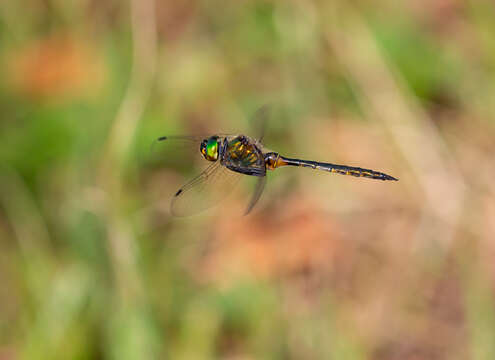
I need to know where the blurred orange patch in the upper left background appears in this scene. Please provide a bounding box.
[7,35,104,99]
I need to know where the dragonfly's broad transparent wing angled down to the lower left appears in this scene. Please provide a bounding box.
[170,161,242,216]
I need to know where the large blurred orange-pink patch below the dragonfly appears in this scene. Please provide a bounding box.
[194,197,343,282]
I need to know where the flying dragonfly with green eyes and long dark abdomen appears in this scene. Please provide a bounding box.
[156,106,398,216]
